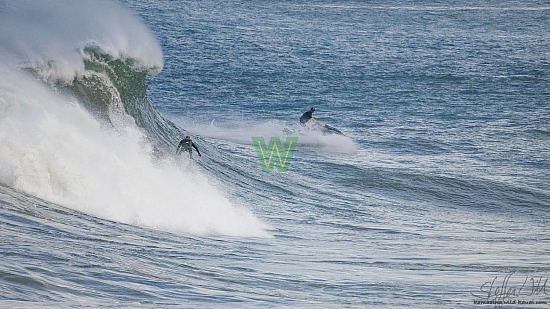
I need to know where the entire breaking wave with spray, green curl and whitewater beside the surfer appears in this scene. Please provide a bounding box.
[0,1,268,236]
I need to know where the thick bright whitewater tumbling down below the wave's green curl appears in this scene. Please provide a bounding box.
[0,69,269,237]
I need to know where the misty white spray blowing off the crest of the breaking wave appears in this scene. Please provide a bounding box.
[0,0,163,81]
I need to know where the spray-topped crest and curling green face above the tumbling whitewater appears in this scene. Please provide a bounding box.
[0,1,178,145]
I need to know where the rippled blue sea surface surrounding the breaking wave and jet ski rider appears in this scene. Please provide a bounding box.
[0,0,550,308]
